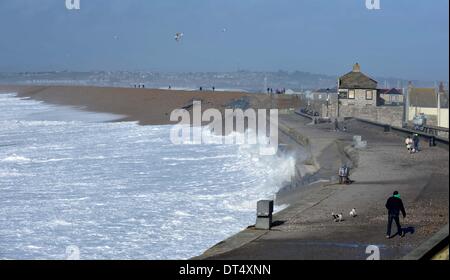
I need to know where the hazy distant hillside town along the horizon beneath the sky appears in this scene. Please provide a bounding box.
[0,69,442,94]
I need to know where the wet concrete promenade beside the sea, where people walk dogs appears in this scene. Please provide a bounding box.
[198,114,449,260]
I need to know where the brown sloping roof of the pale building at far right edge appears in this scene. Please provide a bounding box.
[409,88,448,108]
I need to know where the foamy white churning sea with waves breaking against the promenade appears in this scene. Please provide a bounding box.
[0,94,295,259]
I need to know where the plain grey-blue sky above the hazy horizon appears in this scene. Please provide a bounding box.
[0,0,449,81]
